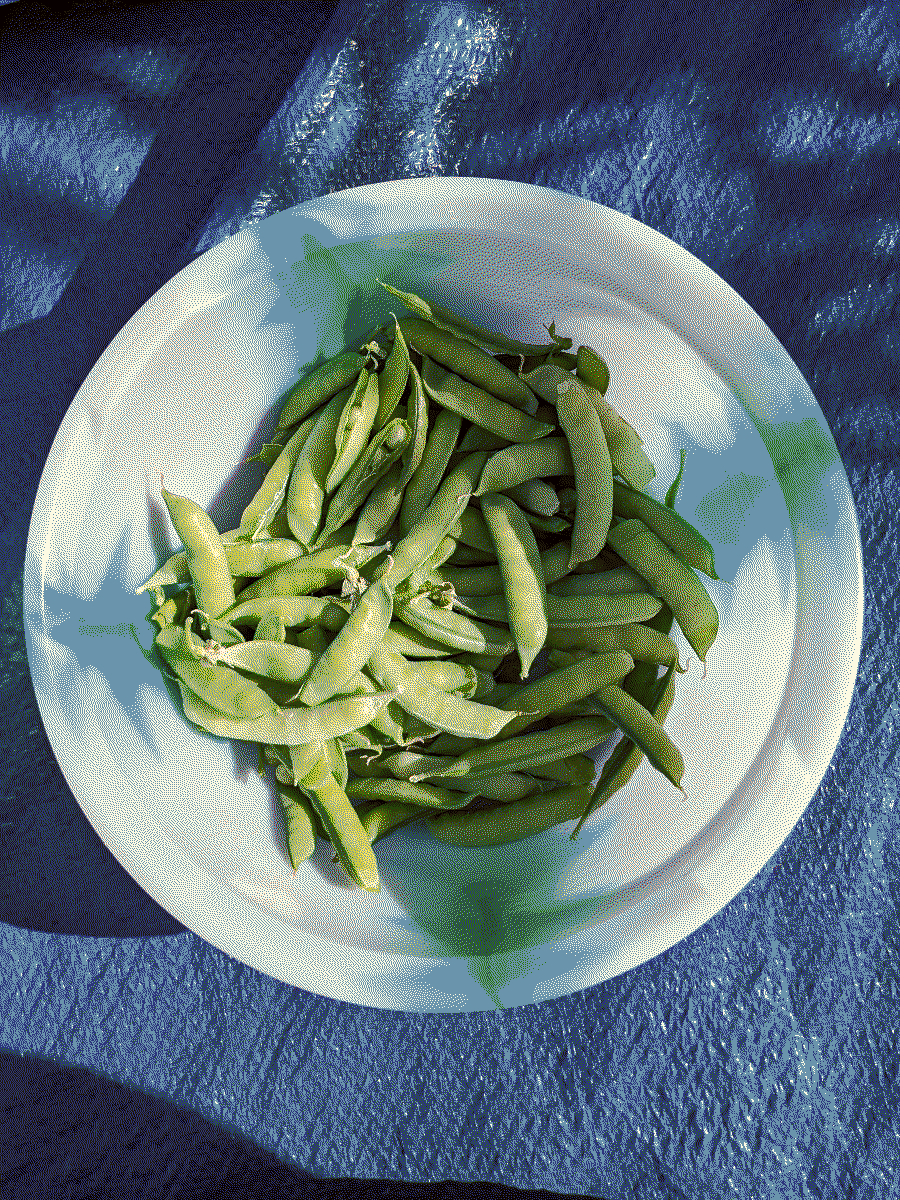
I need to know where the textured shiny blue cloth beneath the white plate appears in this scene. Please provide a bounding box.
[0,0,900,1200]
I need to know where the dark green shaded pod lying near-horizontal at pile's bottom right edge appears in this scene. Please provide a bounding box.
[427,787,590,847]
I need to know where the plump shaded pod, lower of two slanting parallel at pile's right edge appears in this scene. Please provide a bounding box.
[610,520,719,662]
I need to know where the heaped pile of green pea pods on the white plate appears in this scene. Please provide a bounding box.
[138,284,719,890]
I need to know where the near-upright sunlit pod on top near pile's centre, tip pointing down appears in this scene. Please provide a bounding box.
[481,492,548,679]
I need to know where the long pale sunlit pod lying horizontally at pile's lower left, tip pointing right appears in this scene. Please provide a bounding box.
[179,680,396,746]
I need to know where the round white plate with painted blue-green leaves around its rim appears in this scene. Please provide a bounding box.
[25,179,863,1012]
